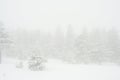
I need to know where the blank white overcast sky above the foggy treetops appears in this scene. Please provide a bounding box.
[0,0,120,31]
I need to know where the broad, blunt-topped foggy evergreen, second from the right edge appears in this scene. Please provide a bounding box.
[89,29,110,63]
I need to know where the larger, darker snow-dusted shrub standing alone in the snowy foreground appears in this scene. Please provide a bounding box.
[28,56,46,71]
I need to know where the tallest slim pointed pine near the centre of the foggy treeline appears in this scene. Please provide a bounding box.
[64,24,76,63]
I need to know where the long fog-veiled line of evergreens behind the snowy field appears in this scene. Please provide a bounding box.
[7,25,120,63]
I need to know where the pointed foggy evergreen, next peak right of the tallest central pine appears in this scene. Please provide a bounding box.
[74,27,89,62]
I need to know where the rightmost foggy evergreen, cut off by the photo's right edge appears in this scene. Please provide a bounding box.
[108,27,120,62]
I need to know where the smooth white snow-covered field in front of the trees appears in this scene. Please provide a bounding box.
[0,59,120,80]
